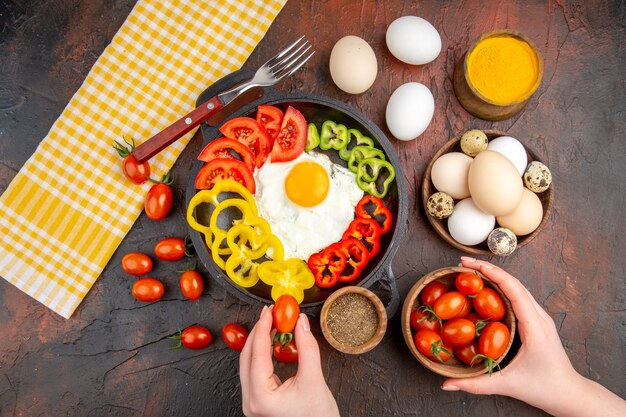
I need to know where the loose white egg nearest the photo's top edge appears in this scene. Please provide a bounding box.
[385,16,441,65]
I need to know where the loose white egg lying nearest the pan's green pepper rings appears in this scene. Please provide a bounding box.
[385,82,435,140]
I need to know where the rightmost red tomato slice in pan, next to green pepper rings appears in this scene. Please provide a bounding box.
[271,106,308,162]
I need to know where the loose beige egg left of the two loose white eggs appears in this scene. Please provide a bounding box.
[329,35,378,94]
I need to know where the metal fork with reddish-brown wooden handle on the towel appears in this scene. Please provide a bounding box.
[132,36,315,162]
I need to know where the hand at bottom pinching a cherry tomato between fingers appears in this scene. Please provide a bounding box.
[239,307,339,417]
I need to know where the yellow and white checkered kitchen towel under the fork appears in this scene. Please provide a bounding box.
[0,0,287,318]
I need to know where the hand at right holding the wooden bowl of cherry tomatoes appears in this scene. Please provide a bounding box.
[442,257,626,416]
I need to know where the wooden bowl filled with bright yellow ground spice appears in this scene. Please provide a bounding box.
[453,29,543,120]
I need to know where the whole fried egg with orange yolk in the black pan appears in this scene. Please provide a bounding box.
[254,152,363,261]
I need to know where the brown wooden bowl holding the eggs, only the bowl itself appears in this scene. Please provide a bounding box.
[422,129,554,256]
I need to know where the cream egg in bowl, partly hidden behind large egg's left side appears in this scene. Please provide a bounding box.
[430,152,473,200]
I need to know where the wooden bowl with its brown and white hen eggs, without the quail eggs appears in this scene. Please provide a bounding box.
[422,129,553,256]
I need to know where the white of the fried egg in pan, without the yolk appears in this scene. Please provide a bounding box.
[254,152,363,260]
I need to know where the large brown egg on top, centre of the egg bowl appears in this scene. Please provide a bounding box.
[468,150,524,216]
